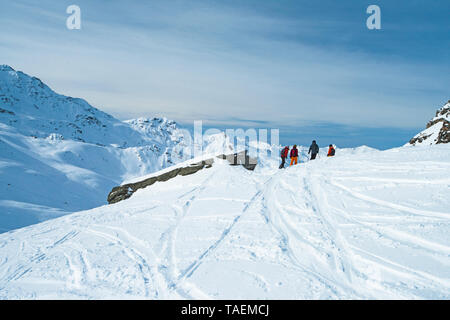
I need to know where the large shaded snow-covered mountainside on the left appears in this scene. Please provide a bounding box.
[0,65,190,232]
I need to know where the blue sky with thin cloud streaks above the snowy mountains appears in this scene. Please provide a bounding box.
[0,0,450,149]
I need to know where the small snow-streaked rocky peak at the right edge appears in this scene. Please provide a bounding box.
[408,100,450,145]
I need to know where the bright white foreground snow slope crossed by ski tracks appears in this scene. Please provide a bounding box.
[0,145,450,299]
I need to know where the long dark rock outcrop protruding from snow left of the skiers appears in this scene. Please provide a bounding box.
[107,150,257,204]
